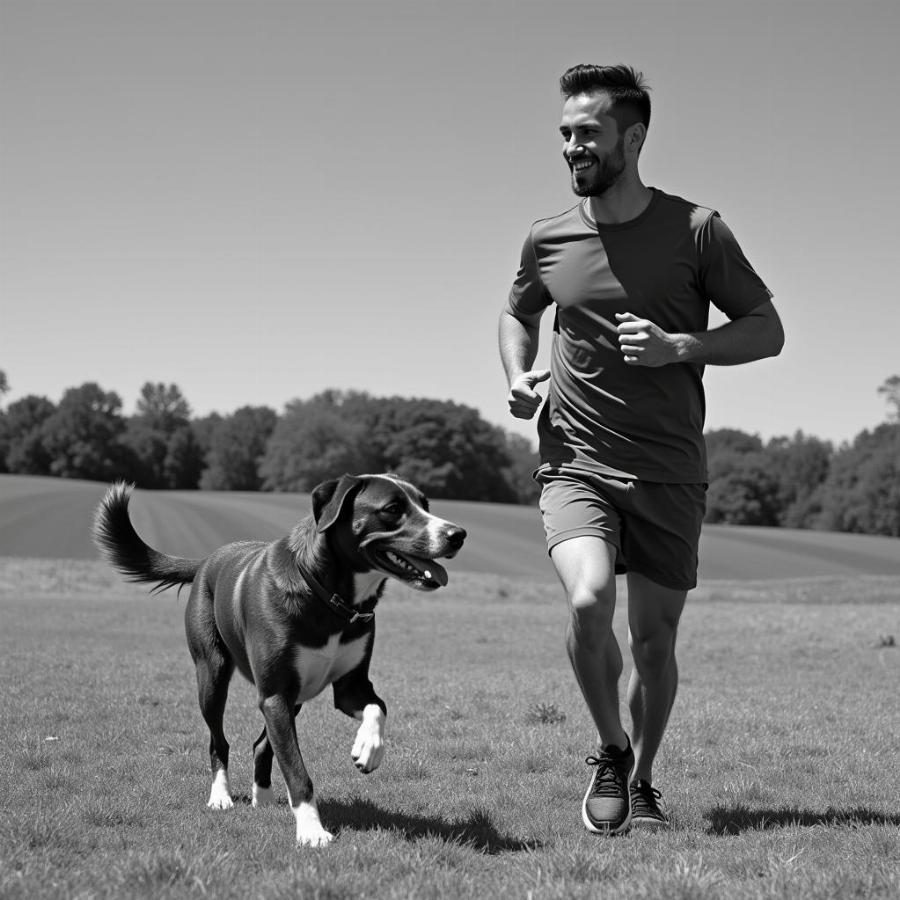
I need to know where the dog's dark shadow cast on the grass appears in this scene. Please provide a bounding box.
[235,795,542,856]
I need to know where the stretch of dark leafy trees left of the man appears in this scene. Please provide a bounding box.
[0,373,537,503]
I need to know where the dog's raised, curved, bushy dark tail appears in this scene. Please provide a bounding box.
[94,481,202,591]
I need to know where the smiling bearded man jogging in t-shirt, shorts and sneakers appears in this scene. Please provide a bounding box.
[500,65,784,834]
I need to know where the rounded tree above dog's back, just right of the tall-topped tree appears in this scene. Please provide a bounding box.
[200,406,278,491]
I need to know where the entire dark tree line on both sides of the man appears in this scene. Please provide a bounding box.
[0,372,900,537]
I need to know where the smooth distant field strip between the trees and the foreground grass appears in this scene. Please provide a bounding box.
[0,475,900,580]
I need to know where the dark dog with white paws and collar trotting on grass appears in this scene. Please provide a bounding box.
[93,475,466,847]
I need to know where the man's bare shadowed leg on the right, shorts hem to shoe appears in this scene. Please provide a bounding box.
[627,572,687,784]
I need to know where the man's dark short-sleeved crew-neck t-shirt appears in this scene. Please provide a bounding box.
[508,189,772,484]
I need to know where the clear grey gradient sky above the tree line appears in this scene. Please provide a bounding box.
[0,0,900,450]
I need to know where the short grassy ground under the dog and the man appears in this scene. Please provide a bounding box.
[0,559,900,900]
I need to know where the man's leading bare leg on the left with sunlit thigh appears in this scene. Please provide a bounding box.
[550,536,628,749]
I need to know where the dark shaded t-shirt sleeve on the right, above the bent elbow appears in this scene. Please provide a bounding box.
[697,213,773,319]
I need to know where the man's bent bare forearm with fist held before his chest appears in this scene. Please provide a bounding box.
[616,300,784,367]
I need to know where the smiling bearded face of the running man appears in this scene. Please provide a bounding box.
[559,91,625,197]
